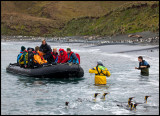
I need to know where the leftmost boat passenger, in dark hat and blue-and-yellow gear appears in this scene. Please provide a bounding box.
[17,46,28,68]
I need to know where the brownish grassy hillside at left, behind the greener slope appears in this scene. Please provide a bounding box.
[1,1,132,36]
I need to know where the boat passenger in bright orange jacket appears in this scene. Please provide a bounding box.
[33,46,47,66]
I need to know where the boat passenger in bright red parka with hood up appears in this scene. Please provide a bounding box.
[57,48,68,63]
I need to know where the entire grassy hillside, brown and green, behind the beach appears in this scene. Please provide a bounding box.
[1,1,159,36]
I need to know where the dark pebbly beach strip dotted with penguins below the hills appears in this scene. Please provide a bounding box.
[1,32,159,45]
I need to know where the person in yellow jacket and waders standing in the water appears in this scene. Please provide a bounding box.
[89,60,111,85]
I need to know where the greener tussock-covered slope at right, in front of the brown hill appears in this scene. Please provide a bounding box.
[61,2,159,36]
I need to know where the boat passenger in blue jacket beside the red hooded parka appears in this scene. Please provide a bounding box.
[67,48,79,64]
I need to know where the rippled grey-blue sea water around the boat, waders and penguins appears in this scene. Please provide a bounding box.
[1,42,159,115]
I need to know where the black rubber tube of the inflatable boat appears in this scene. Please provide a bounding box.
[6,64,84,78]
